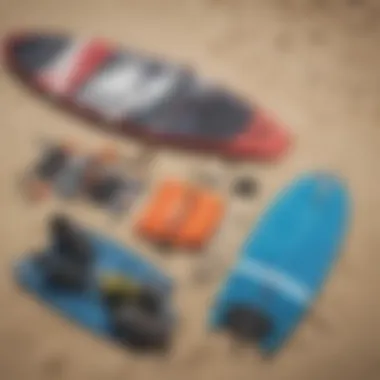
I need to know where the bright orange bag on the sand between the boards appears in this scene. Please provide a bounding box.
[136,180,224,249]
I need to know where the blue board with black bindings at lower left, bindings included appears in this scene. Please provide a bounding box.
[14,216,176,350]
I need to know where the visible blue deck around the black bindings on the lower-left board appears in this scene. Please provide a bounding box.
[14,232,175,338]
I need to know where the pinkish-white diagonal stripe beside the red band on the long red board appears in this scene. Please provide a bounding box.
[43,39,90,93]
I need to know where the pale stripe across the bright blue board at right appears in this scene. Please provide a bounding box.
[235,260,312,305]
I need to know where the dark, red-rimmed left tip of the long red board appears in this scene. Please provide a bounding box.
[3,32,70,74]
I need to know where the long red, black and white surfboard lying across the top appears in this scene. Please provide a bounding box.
[4,32,289,159]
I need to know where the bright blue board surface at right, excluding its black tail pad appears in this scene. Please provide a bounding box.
[209,173,350,353]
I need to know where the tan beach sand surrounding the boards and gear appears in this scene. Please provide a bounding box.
[0,0,380,380]
